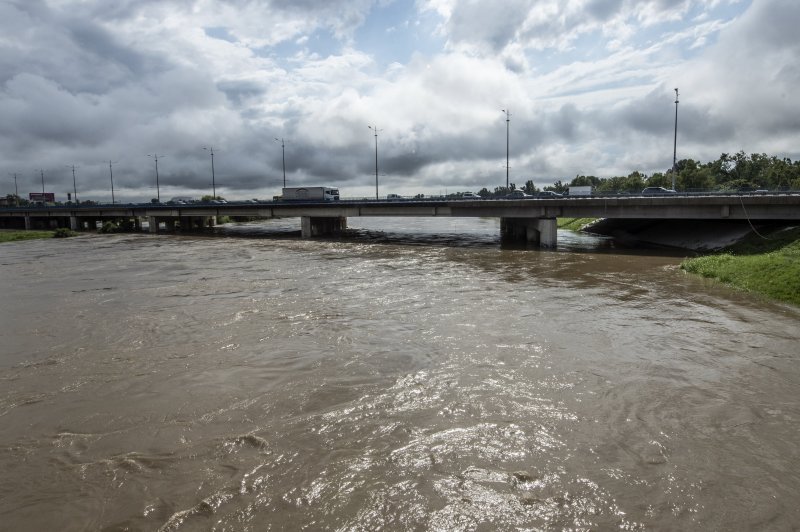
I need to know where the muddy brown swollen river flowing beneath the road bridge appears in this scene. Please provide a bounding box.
[0,219,800,531]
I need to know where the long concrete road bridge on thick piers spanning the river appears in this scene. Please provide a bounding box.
[0,191,800,247]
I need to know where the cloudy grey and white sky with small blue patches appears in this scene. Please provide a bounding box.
[0,0,800,202]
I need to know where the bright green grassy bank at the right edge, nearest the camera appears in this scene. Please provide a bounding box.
[681,227,800,306]
